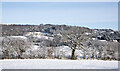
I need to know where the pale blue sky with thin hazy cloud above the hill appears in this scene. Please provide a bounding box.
[2,2,118,30]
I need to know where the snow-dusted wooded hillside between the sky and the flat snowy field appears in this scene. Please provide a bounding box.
[0,24,120,60]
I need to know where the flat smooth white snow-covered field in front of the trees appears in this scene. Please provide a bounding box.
[0,59,118,69]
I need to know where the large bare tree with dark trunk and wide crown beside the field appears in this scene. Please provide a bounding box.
[62,31,86,59]
